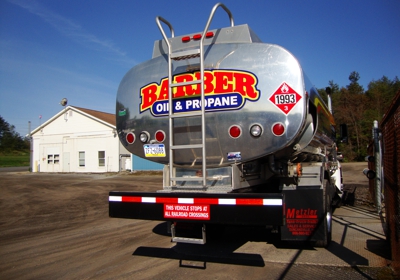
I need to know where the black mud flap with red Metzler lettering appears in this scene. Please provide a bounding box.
[281,188,330,244]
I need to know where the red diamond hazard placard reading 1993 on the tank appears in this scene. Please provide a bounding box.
[269,82,301,115]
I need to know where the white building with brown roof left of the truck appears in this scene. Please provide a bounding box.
[31,106,132,172]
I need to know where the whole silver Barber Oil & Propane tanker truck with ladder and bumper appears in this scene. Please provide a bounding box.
[109,3,343,246]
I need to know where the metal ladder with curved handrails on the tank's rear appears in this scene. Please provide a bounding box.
[156,3,234,188]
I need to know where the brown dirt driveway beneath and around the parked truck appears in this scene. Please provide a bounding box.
[0,165,392,279]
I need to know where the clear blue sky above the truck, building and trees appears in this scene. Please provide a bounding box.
[0,0,400,135]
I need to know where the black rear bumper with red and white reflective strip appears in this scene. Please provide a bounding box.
[109,191,285,226]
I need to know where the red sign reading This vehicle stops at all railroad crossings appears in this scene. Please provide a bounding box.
[164,204,210,220]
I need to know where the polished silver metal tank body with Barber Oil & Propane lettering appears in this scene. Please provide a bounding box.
[116,25,335,167]
